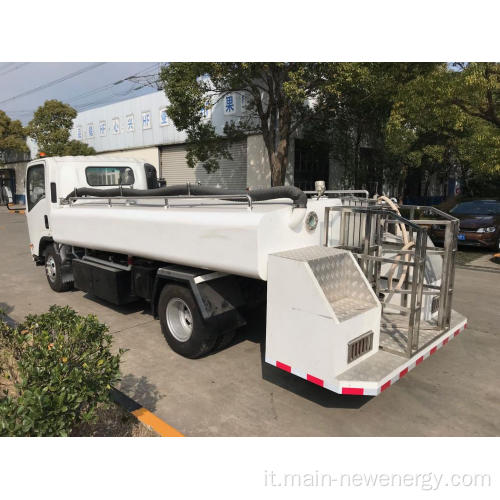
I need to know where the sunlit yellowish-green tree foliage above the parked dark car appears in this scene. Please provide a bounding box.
[386,63,500,195]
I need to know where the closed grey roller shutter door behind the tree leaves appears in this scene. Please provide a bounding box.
[160,139,247,189]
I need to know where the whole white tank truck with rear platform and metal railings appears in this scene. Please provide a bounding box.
[26,156,466,395]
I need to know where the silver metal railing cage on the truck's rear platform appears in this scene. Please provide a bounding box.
[323,198,458,357]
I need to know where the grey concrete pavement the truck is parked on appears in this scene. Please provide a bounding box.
[0,207,500,436]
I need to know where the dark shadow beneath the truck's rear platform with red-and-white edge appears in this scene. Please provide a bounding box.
[228,307,373,409]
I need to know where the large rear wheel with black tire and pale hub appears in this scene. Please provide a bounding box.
[158,284,217,359]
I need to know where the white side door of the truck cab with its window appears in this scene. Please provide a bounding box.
[26,162,50,257]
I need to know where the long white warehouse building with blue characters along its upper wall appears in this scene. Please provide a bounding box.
[67,91,330,189]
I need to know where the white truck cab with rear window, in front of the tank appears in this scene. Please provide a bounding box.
[26,156,158,264]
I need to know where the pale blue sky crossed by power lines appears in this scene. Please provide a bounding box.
[0,62,161,125]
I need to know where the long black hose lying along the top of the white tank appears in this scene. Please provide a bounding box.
[66,184,307,208]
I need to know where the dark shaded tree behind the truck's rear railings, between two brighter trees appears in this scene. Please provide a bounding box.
[304,63,436,192]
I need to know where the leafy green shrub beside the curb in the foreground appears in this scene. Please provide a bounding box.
[0,306,123,436]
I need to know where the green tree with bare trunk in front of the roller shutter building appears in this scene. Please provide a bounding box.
[160,63,336,186]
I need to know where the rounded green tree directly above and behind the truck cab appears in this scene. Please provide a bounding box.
[27,99,95,156]
